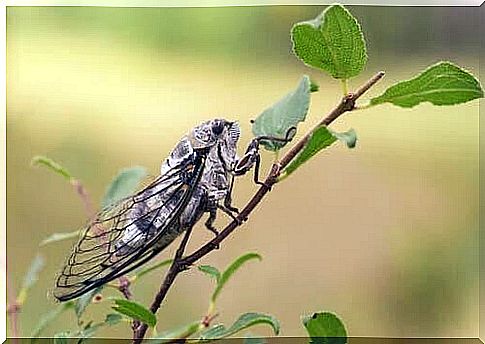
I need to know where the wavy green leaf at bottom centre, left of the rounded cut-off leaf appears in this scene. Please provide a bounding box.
[201,313,280,340]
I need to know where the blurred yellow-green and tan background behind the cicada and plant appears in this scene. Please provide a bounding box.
[7,6,485,337]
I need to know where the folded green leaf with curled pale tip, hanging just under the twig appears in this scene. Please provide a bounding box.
[284,127,357,176]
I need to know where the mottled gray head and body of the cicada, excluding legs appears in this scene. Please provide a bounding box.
[115,119,240,256]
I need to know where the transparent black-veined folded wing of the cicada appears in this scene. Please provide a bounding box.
[54,154,205,301]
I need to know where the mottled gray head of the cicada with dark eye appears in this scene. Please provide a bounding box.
[188,119,241,152]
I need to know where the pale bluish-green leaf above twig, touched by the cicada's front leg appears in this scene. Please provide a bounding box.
[252,75,311,151]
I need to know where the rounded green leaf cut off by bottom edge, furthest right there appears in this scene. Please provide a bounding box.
[302,312,347,344]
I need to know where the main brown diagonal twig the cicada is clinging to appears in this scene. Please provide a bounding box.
[133,72,384,344]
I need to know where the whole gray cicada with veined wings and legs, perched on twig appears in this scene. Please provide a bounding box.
[54,119,290,301]
